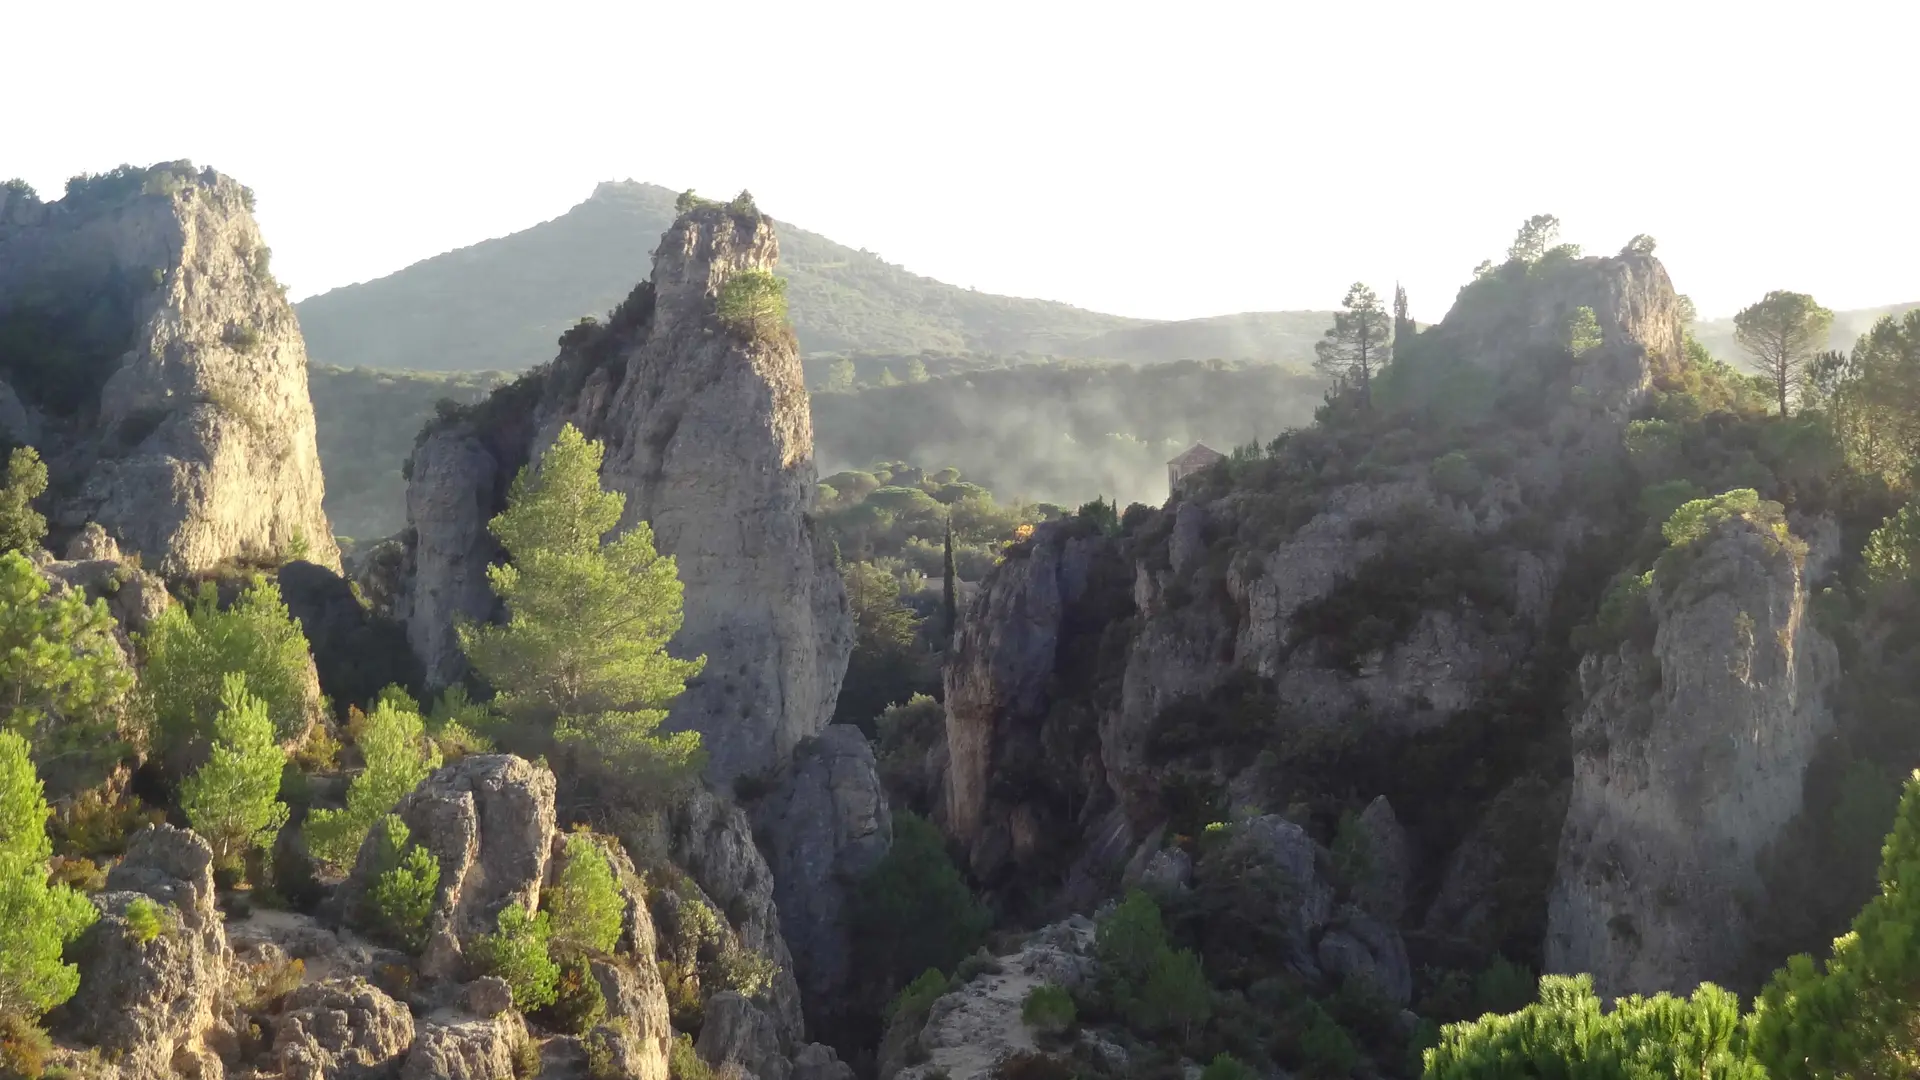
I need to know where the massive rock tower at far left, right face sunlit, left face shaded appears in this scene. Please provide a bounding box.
[0,161,340,575]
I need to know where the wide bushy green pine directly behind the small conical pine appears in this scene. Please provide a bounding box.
[138,580,313,755]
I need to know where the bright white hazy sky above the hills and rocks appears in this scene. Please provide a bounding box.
[0,0,1920,319]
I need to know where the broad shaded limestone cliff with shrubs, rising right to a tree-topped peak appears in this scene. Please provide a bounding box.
[943,254,1682,907]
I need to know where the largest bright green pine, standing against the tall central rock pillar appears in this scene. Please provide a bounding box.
[459,425,707,792]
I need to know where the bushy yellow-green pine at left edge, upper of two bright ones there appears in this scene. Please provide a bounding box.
[0,552,134,761]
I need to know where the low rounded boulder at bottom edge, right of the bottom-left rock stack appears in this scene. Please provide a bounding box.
[273,978,413,1080]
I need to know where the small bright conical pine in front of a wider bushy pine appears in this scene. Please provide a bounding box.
[180,673,286,869]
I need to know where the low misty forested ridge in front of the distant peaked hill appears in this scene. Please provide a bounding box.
[311,354,1325,540]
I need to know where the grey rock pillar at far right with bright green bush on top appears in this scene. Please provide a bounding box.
[1546,503,1839,995]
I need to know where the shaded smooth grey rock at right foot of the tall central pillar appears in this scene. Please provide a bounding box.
[755,724,893,1032]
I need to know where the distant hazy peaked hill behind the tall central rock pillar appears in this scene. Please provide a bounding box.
[296,181,1323,371]
